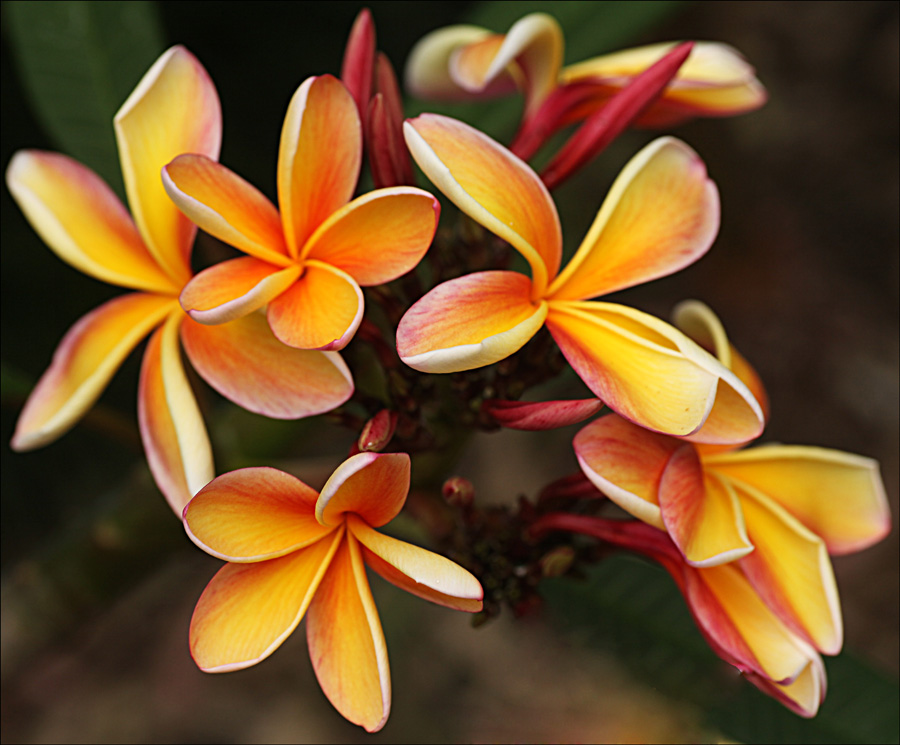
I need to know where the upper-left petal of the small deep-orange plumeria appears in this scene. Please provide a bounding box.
[162,154,290,266]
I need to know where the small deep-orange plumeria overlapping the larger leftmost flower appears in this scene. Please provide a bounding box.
[163,75,439,350]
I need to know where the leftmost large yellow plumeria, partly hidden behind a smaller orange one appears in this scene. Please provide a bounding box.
[6,46,353,515]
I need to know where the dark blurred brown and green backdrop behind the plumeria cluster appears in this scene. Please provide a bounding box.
[0,2,900,742]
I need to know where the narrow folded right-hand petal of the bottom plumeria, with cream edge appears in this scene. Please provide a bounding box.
[347,514,484,613]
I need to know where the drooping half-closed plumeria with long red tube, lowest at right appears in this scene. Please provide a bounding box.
[532,513,826,718]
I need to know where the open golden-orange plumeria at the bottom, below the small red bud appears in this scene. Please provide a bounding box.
[184,453,483,732]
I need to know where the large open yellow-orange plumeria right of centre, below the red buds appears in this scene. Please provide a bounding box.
[397,114,763,442]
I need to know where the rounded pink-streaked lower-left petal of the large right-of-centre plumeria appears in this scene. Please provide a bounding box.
[397,271,547,373]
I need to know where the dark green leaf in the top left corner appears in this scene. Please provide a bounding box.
[4,1,164,196]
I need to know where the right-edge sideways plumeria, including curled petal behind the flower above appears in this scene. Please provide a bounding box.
[574,303,890,654]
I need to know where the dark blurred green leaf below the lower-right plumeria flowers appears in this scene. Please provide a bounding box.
[541,555,900,743]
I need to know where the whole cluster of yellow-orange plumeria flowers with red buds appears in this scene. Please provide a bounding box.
[6,11,890,731]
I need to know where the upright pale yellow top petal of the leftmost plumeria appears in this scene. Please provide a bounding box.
[113,46,222,287]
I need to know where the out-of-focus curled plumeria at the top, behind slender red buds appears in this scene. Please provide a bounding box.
[405,13,766,138]
